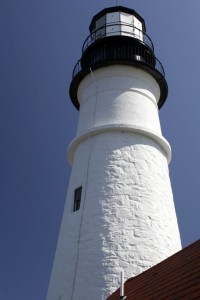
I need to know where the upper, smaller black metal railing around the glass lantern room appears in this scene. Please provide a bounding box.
[82,23,154,52]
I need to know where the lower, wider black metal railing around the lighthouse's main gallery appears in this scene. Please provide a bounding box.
[72,45,165,78]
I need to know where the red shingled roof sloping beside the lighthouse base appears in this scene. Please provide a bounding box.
[107,240,200,300]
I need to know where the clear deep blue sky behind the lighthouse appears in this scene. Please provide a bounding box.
[0,0,200,300]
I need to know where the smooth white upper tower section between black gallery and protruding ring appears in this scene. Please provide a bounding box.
[77,65,161,135]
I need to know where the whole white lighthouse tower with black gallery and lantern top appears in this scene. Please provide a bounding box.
[47,6,181,300]
